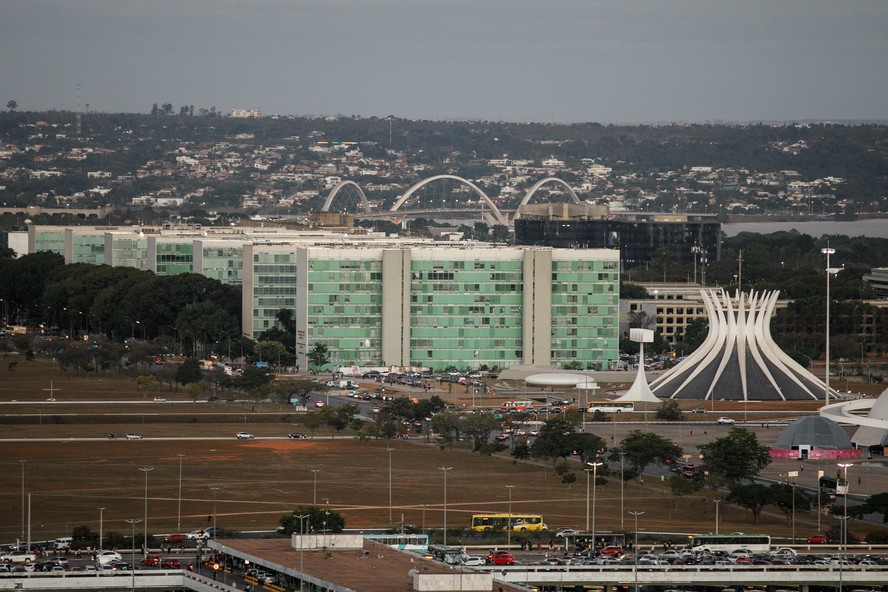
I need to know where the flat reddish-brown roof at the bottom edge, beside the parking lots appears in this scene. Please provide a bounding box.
[208,535,526,592]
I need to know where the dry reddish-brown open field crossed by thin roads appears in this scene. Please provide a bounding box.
[0,358,884,543]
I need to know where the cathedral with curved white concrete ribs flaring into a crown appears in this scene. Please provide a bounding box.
[651,290,826,401]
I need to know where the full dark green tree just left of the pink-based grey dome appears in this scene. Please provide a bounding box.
[700,428,771,484]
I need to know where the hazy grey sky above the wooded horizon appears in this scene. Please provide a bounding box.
[0,0,888,123]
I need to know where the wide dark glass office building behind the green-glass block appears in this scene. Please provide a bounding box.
[515,206,721,269]
